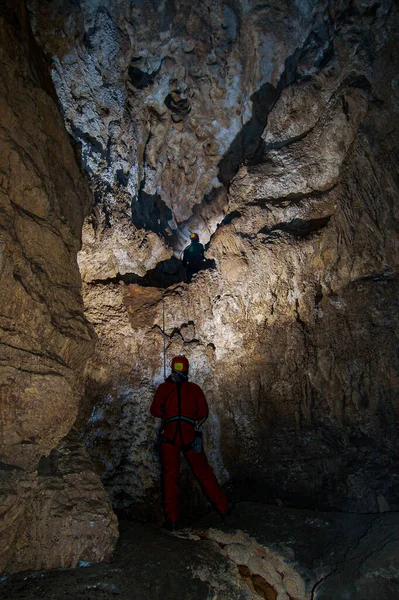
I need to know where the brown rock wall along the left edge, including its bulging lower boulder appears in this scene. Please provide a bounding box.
[0,2,117,572]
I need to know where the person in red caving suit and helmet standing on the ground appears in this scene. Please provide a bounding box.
[151,355,230,531]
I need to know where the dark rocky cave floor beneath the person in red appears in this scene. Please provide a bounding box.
[0,502,399,600]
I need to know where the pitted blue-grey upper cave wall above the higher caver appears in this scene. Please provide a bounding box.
[29,0,323,262]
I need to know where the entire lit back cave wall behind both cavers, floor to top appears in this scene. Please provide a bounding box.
[30,0,399,512]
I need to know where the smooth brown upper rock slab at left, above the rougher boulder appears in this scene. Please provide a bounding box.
[0,5,94,468]
